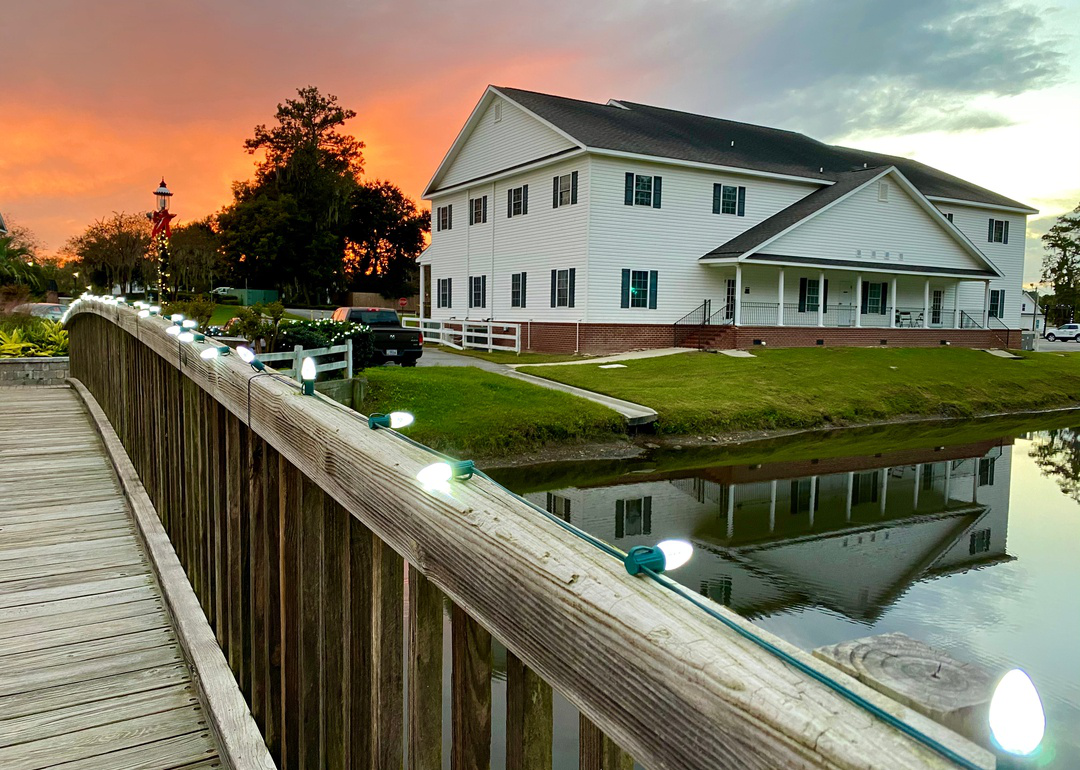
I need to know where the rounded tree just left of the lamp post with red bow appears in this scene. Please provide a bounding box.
[65,212,157,293]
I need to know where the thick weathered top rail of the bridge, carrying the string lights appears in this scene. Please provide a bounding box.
[68,300,993,770]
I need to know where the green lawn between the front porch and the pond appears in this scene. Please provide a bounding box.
[524,348,1080,433]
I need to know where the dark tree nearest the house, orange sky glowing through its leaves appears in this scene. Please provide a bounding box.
[345,181,431,297]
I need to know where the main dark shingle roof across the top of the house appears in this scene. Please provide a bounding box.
[496,86,1028,208]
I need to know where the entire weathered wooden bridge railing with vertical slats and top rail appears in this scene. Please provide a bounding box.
[68,300,993,770]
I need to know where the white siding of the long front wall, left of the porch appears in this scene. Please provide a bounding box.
[588,157,819,324]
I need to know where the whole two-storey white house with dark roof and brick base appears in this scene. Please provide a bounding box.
[420,86,1036,351]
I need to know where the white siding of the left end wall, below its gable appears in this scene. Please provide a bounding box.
[429,157,590,323]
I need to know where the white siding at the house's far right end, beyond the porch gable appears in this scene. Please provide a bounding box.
[939,203,1030,328]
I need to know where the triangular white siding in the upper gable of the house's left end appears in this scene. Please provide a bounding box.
[436,96,577,188]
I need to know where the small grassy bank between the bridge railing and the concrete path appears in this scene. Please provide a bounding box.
[360,366,625,458]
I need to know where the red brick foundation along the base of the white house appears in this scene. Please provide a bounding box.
[509,323,1021,353]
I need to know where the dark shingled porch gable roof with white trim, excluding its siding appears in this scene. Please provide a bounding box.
[700,165,1002,276]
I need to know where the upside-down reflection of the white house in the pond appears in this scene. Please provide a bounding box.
[527,440,1012,622]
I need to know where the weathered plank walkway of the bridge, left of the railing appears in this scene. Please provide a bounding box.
[0,388,221,770]
